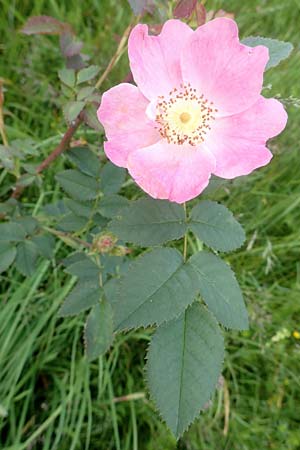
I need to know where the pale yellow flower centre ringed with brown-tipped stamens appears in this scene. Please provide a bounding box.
[155,83,217,145]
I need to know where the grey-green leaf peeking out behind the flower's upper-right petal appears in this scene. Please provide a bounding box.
[242,36,294,70]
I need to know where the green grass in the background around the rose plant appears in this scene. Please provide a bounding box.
[0,0,300,450]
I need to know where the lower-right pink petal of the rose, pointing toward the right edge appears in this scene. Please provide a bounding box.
[205,97,287,178]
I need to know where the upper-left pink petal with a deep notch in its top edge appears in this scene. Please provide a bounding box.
[128,20,193,100]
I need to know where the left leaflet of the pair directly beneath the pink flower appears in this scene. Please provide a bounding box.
[109,198,187,246]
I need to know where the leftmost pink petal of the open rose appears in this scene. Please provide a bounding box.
[97,83,160,167]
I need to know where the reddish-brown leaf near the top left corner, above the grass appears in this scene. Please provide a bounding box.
[20,16,72,34]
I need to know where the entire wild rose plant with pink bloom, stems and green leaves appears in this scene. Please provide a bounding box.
[0,1,292,437]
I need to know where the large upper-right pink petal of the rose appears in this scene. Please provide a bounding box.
[181,18,269,115]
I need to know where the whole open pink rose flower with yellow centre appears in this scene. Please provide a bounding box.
[98,18,287,203]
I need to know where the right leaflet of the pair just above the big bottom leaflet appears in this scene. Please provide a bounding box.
[187,252,248,330]
